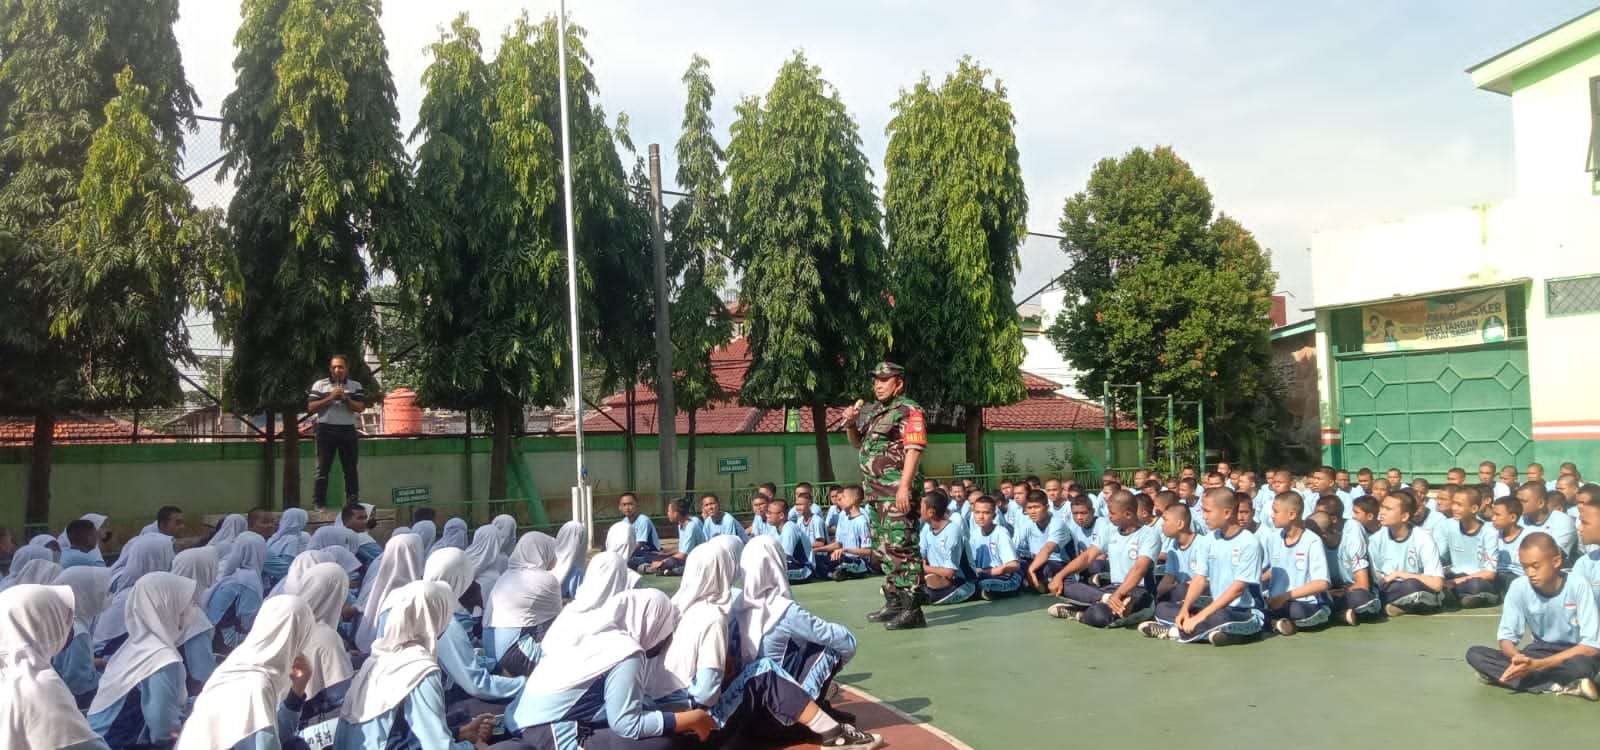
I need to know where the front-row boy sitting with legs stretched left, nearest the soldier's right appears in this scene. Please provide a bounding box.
[1048,489,1162,627]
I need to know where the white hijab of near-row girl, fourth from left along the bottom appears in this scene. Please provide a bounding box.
[339,580,456,724]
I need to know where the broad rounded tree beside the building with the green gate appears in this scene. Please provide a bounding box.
[1050,147,1277,450]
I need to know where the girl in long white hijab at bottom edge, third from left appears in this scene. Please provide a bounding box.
[178,596,315,750]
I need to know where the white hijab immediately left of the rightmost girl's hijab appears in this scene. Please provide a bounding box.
[662,544,739,694]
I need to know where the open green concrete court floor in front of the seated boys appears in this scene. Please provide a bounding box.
[646,577,1600,750]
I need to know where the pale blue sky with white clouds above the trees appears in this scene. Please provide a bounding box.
[178,0,1594,321]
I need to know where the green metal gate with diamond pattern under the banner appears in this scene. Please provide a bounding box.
[1338,342,1533,481]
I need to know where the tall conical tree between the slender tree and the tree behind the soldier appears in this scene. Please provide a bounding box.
[728,53,890,481]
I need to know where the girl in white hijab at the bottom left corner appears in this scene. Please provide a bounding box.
[0,585,110,750]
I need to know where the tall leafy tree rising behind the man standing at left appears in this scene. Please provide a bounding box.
[214,0,406,505]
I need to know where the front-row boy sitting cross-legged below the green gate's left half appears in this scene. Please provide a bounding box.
[1366,489,1445,617]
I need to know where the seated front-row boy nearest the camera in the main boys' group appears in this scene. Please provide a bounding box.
[1139,488,1264,646]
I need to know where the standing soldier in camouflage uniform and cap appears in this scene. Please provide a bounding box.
[845,361,928,630]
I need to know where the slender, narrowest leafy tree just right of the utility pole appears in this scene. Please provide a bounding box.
[667,54,733,488]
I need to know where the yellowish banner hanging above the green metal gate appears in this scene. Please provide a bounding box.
[1362,289,1507,353]
